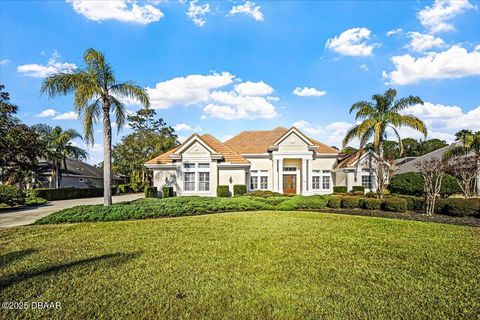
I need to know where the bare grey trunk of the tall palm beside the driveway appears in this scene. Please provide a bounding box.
[103,103,112,206]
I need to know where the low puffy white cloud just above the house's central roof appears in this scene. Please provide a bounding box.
[203,91,278,120]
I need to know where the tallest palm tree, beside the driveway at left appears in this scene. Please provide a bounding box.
[41,49,150,206]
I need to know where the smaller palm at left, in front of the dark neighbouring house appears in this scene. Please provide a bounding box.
[34,124,87,189]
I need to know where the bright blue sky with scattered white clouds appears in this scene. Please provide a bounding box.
[0,0,480,163]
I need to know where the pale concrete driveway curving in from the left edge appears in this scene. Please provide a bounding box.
[0,193,144,227]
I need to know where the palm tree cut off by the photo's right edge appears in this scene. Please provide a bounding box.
[443,129,480,196]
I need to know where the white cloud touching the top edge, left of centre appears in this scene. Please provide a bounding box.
[67,0,164,24]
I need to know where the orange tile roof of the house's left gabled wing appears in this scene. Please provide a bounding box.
[147,134,250,164]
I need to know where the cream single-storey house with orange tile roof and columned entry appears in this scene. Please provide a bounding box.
[145,127,375,196]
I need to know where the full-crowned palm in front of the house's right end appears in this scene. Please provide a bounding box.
[343,89,427,197]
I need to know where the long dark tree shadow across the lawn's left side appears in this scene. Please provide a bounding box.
[0,249,140,289]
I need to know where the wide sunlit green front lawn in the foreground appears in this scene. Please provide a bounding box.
[0,211,480,319]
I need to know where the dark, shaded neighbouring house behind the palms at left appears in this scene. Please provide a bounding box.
[37,159,121,188]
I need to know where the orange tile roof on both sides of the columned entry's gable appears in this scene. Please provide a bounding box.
[225,127,338,154]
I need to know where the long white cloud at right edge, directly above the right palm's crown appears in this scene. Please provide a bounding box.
[383,45,480,85]
